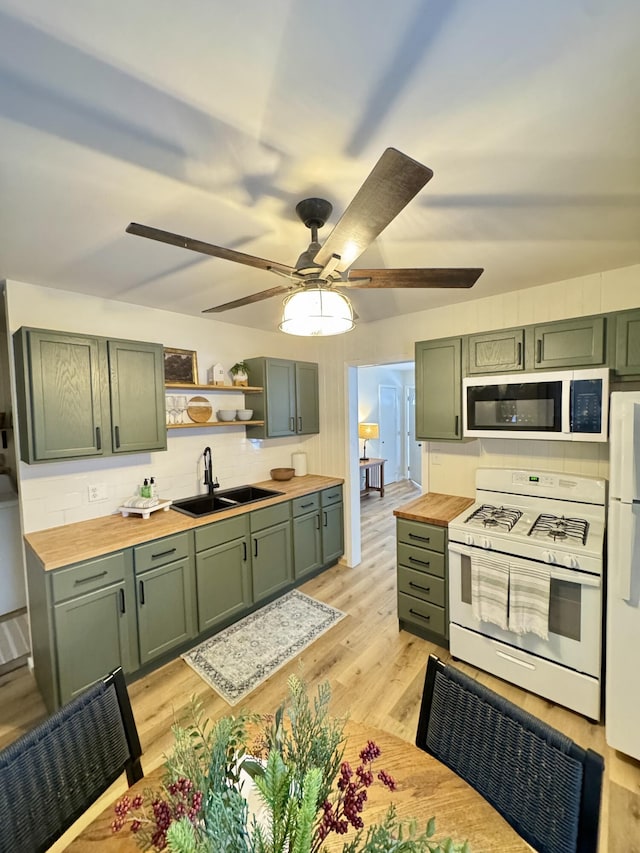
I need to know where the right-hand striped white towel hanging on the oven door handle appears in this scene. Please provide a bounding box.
[509,563,551,640]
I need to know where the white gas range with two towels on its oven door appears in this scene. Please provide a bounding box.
[449,468,606,720]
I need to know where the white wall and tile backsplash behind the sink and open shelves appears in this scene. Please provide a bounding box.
[6,281,330,532]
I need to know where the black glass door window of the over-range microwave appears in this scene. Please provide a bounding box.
[467,380,562,432]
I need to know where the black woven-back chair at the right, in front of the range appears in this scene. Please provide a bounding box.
[416,655,604,853]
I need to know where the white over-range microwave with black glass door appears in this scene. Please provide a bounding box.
[462,368,609,441]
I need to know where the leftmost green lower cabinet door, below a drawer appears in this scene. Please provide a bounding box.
[53,582,137,705]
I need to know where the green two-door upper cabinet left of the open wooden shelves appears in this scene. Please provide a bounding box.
[14,328,167,463]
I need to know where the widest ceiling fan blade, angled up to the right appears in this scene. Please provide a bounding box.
[314,148,433,272]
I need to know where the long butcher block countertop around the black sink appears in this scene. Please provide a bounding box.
[24,474,344,571]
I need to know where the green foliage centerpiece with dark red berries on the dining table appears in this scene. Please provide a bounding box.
[113,676,468,853]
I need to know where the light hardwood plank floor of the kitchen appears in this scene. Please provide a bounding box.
[0,481,640,853]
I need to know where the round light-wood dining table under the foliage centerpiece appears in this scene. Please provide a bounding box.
[66,721,532,853]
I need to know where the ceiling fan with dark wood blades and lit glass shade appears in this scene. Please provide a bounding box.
[126,148,483,335]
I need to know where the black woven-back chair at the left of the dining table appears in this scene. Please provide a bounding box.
[0,669,143,853]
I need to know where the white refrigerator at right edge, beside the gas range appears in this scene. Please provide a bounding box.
[605,391,640,759]
